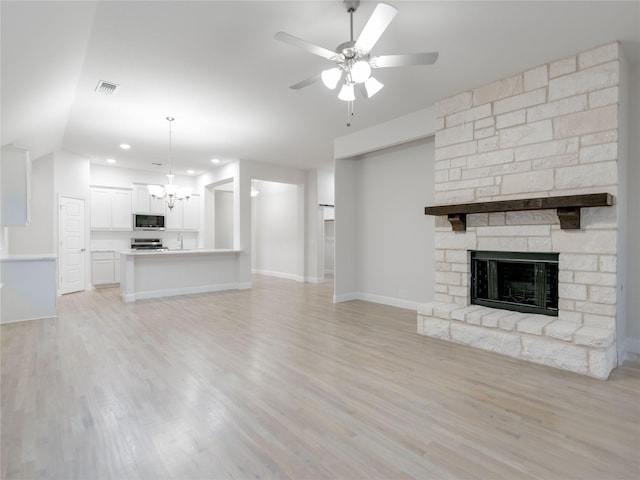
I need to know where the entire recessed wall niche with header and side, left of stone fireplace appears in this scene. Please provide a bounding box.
[334,108,435,308]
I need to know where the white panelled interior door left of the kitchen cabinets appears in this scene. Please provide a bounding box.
[58,196,86,295]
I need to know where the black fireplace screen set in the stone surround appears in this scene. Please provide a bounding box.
[471,251,558,316]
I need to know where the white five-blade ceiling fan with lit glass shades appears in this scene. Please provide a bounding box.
[274,0,438,105]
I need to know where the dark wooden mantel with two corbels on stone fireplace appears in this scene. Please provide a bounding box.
[424,193,614,232]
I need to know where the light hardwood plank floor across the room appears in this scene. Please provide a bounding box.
[1,277,640,480]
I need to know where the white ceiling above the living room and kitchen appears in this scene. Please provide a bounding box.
[1,0,640,174]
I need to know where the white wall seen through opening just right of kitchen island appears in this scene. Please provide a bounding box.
[251,182,304,281]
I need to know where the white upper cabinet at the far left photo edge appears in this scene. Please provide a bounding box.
[0,147,31,227]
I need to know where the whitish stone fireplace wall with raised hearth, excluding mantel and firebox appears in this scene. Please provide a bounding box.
[418,43,620,378]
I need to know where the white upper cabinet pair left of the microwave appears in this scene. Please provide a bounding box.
[91,187,133,231]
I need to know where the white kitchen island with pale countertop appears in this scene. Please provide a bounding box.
[118,249,245,302]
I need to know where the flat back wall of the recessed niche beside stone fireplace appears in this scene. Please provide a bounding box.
[356,139,435,308]
